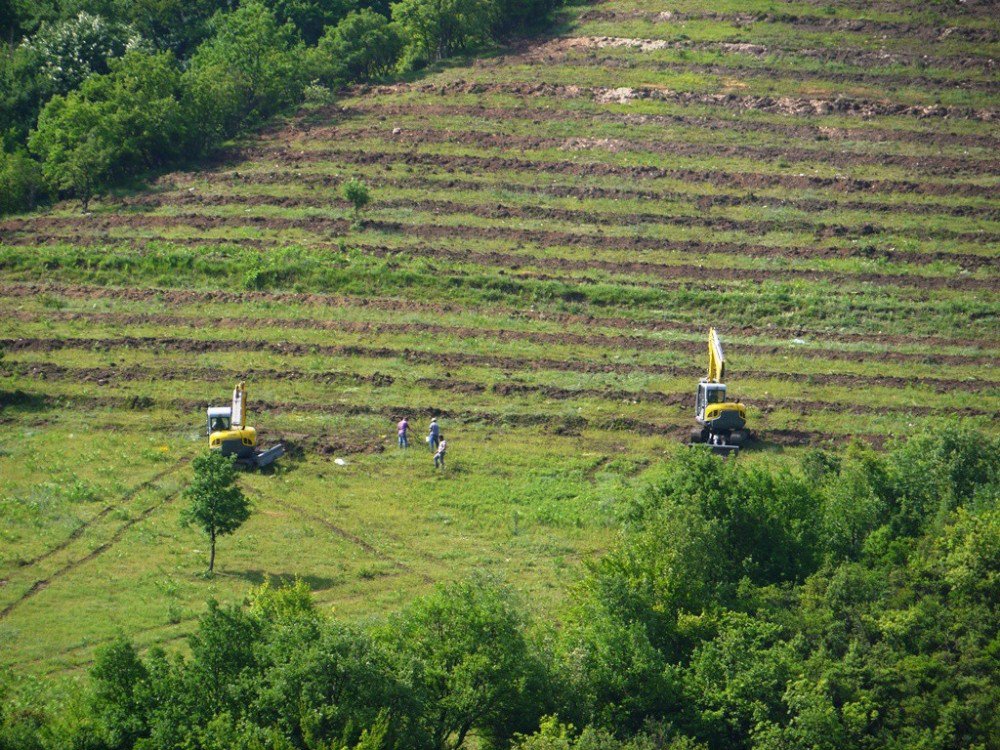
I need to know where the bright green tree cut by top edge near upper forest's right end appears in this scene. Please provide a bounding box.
[392,0,497,65]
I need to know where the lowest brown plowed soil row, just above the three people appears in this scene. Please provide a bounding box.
[0,388,884,446]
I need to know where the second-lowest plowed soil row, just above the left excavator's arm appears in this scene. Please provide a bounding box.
[0,362,1000,418]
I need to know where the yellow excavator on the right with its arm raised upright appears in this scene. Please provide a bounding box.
[691,328,749,456]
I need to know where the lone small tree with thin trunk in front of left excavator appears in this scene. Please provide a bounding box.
[181,451,250,573]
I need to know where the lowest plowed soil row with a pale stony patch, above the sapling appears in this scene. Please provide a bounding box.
[284,124,1000,177]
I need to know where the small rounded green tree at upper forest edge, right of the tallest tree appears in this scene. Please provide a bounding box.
[310,8,403,86]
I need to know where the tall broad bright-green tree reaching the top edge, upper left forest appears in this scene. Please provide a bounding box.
[185,0,305,135]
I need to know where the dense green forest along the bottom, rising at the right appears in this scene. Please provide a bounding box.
[0,428,1000,750]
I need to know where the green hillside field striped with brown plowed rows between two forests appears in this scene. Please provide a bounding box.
[0,0,1000,673]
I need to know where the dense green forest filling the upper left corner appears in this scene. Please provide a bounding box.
[0,0,557,214]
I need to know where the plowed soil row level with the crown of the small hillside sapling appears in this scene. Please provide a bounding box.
[199,167,1000,221]
